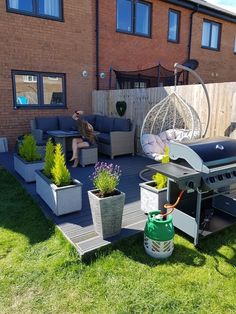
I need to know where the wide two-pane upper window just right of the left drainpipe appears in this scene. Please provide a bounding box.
[116,0,151,37]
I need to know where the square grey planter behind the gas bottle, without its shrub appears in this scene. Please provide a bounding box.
[139,181,167,213]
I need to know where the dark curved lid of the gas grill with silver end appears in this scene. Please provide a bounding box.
[170,137,236,173]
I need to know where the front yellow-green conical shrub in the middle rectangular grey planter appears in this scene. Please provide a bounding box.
[51,144,72,186]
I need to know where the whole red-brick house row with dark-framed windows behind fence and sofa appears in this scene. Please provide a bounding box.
[0,0,236,148]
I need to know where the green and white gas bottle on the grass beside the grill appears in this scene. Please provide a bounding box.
[144,210,175,259]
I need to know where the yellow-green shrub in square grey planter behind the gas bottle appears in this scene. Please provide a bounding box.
[139,148,170,213]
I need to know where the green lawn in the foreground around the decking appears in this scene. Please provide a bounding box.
[0,168,236,314]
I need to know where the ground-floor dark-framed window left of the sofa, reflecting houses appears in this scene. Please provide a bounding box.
[12,71,66,108]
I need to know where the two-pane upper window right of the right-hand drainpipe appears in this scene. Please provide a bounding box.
[202,21,221,50]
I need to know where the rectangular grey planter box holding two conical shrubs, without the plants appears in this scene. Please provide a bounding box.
[36,171,82,216]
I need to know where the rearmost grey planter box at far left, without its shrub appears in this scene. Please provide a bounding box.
[14,154,44,182]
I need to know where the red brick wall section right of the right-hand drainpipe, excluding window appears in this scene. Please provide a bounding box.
[191,13,236,83]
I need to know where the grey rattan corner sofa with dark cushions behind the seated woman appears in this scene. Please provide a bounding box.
[30,114,135,159]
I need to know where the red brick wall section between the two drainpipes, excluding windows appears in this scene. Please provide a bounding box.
[100,0,191,88]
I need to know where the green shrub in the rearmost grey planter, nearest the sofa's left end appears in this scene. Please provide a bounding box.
[19,134,42,161]
